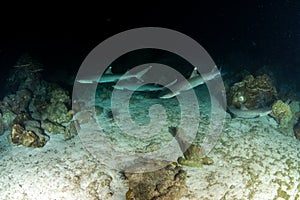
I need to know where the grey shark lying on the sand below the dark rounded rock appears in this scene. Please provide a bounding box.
[227,106,272,119]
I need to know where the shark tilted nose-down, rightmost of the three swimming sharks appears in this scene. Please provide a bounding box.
[159,66,221,99]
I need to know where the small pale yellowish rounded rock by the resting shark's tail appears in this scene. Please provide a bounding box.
[271,100,293,127]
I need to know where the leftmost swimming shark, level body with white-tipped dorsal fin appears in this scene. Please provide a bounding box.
[76,66,152,84]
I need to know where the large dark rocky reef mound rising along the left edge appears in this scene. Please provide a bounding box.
[0,55,77,147]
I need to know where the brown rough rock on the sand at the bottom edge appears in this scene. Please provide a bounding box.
[125,163,187,200]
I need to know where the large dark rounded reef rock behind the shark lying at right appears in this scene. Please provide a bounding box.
[227,74,277,109]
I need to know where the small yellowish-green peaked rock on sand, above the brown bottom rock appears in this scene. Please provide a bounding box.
[178,144,213,168]
